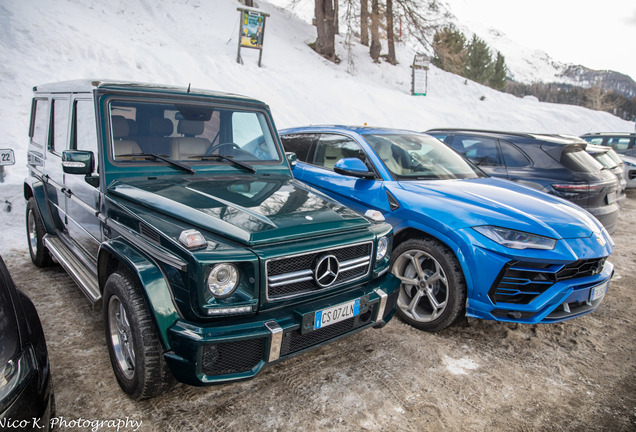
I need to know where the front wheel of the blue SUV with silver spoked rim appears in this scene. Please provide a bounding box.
[391,239,466,331]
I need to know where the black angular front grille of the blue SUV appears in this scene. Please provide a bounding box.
[488,257,607,304]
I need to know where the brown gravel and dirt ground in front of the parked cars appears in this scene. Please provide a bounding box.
[4,191,636,431]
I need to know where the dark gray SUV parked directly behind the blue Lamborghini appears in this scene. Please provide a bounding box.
[426,129,620,233]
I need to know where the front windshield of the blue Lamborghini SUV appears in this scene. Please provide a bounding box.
[364,134,485,180]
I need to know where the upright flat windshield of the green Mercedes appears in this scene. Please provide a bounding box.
[109,100,281,166]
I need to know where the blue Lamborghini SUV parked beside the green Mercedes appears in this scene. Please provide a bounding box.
[281,126,614,331]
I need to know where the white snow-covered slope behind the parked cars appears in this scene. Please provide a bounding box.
[0,0,634,253]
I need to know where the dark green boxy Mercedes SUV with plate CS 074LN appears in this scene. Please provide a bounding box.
[24,80,399,398]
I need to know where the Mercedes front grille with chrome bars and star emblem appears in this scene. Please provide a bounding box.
[266,242,373,300]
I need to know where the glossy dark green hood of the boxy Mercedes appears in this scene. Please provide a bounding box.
[107,176,369,245]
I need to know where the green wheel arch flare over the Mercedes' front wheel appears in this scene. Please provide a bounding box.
[97,239,180,350]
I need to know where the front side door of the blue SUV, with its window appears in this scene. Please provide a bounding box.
[286,133,390,213]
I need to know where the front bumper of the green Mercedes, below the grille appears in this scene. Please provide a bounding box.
[164,274,400,385]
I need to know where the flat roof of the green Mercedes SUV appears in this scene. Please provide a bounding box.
[33,79,263,104]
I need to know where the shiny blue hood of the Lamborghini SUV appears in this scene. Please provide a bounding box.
[399,177,602,239]
